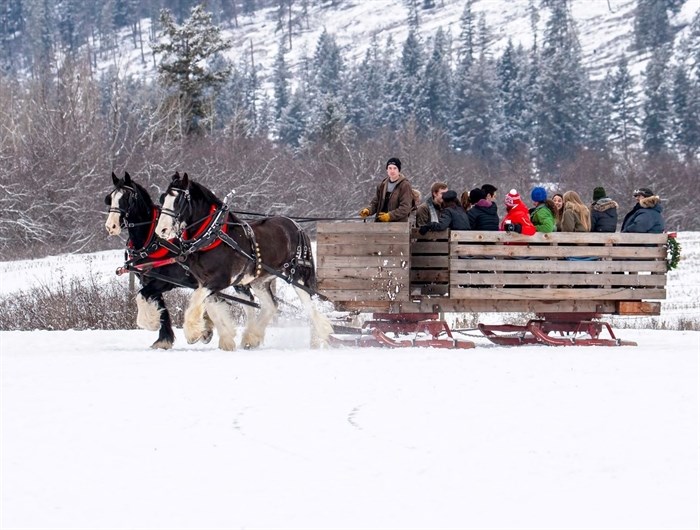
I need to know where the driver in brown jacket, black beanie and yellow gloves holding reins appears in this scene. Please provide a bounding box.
[360,158,414,223]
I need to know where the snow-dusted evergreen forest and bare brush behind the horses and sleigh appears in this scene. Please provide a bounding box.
[0,0,700,258]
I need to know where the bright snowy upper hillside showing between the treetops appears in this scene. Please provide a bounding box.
[112,0,700,89]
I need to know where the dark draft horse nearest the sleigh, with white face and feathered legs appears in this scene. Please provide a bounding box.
[156,173,333,350]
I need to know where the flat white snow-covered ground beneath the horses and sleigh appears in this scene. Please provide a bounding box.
[0,233,700,529]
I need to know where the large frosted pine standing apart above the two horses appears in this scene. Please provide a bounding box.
[153,6,231,133]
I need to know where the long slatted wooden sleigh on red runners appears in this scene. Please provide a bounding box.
[317,223,668,348]
